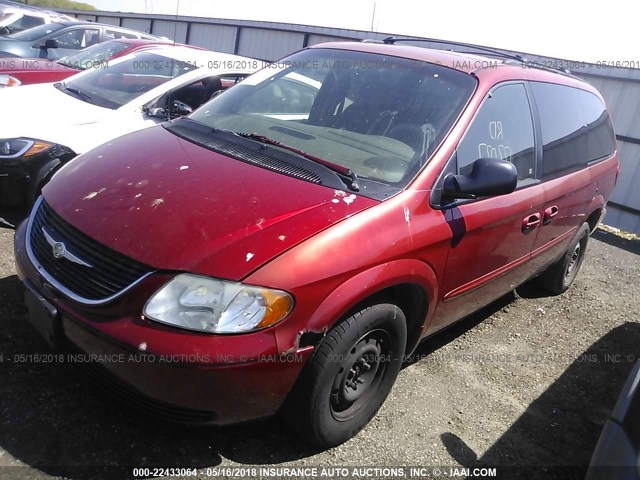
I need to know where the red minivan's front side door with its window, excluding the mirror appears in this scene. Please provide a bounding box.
[429,83,544,332]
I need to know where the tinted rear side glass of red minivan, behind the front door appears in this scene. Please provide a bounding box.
[531,82,616,180]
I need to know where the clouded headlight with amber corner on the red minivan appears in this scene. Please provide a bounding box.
[143,274,293,333]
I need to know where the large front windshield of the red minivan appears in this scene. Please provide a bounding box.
[190,49,476,187]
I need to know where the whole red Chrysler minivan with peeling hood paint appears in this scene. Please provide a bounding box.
[13,40,619,446]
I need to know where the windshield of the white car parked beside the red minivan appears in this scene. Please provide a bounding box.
[61,52,197,109]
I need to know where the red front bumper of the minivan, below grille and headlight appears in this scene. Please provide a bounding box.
[15,224,312,424]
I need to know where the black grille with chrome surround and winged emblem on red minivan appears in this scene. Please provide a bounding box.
[28,197,153,303]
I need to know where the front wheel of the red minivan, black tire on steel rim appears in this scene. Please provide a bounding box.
[281,303,407,448]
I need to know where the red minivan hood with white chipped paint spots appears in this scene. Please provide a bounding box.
[43,126,378,280]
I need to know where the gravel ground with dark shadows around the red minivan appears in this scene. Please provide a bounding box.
[0,230,640,479]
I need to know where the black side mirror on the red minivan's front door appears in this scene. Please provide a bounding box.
[442,158,518,198]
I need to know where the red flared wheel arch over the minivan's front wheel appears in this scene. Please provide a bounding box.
[276,259,438,352]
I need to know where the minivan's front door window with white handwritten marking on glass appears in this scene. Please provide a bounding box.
[458,83,536,185]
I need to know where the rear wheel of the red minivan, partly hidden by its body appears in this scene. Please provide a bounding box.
[538,223,590,295]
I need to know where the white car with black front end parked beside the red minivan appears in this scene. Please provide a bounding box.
[0,46,262,226]
